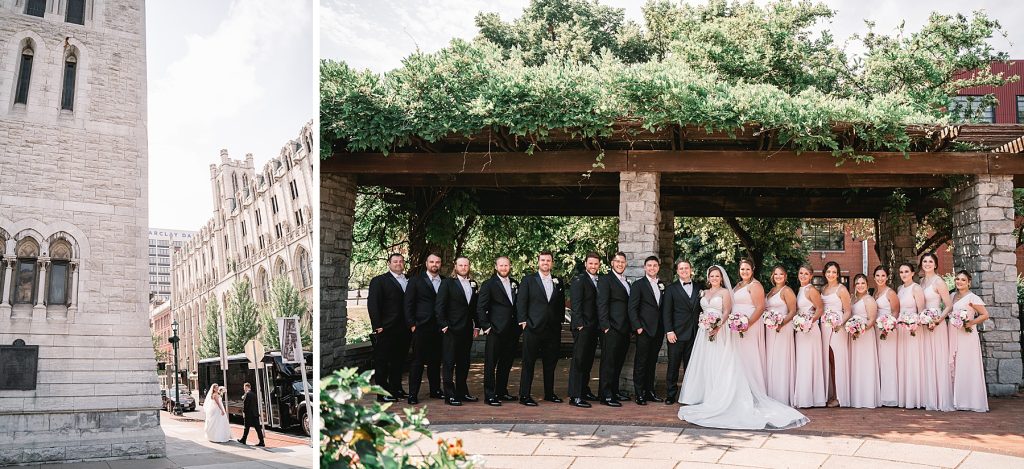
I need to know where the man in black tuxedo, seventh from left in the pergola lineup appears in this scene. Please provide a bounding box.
[597,248,630,408]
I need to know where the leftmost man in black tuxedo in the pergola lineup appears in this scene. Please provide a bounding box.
[367,253,410,402]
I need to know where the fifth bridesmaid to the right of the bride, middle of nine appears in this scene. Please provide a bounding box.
[850,273,879,409]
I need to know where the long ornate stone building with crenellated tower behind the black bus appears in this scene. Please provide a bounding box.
[171,122,316,389]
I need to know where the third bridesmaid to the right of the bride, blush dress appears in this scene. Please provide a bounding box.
[792,265,828,408]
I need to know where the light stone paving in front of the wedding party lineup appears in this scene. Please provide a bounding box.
[414,423,1024,469]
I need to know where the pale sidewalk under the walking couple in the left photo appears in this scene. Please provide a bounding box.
[14,412,318,469]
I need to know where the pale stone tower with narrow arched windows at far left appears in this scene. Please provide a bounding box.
[0,0,165,460]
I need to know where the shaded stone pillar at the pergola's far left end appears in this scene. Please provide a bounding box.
[319,174,355,375]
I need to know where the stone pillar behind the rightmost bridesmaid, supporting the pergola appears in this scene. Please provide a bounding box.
[951,175,1022,395]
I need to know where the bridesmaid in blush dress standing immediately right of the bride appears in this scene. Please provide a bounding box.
[729,259,767,394]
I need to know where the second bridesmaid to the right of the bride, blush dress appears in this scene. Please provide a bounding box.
[765,265,797,406]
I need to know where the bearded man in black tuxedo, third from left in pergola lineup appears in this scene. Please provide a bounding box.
[435,256,479,406]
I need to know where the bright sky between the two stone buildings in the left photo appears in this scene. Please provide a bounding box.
[145,0,318,230]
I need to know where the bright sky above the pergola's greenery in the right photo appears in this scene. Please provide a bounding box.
[319,0,1024,73]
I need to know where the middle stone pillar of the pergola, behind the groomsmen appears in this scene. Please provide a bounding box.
[618,171,662,393]
